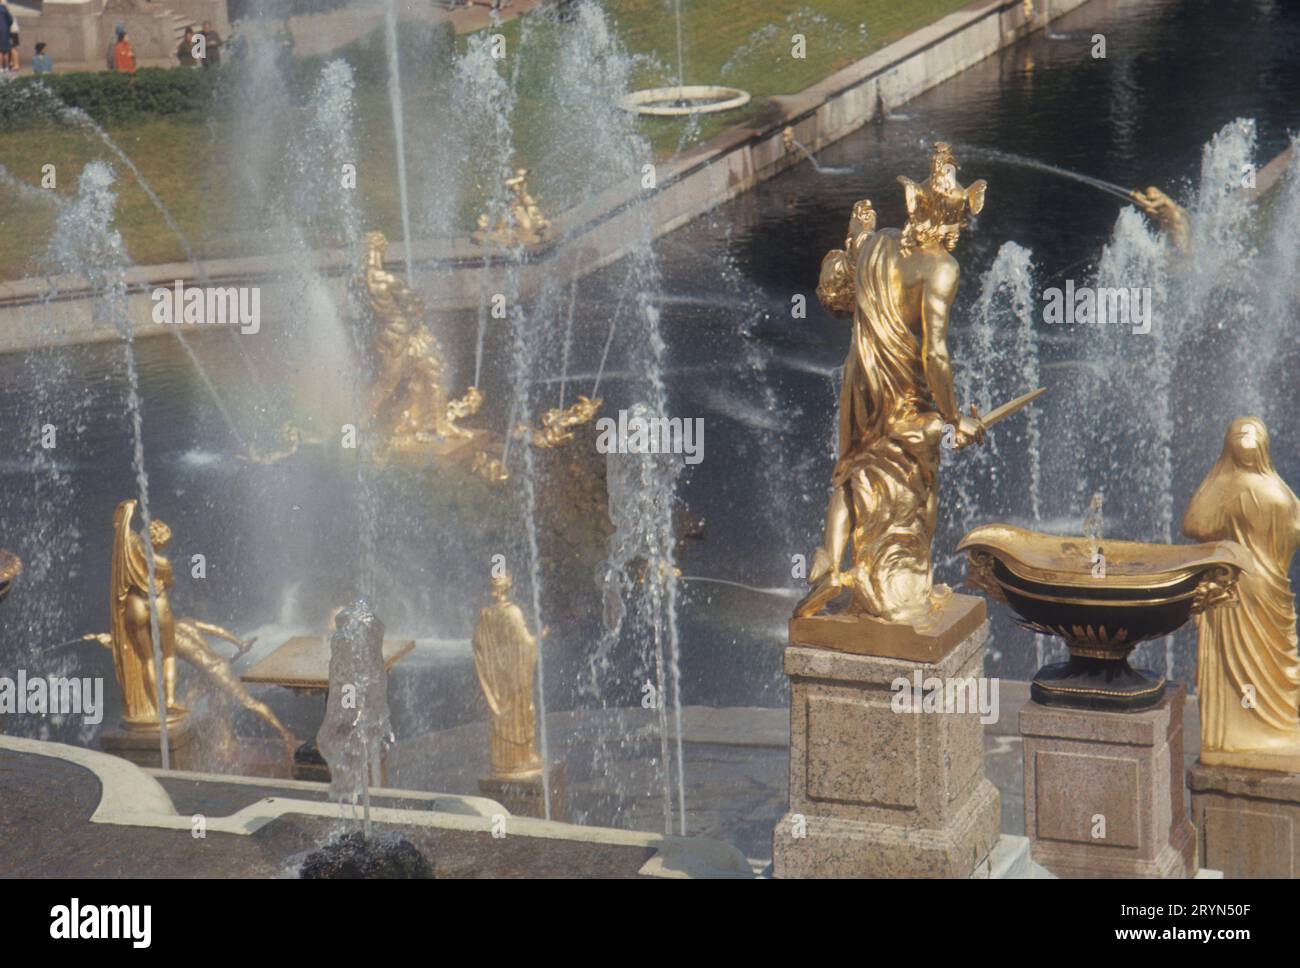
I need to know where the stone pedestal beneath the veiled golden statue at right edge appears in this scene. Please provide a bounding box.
[1187,761,1300,877]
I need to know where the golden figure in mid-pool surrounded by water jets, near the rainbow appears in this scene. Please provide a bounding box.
[361,231,484,448]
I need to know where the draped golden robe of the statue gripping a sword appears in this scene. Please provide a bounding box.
[832,229,944,621]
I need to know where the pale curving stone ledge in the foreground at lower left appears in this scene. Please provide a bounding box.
[0,735,754,878]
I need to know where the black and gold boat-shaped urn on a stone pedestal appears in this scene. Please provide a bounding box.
[957,525,1249,711]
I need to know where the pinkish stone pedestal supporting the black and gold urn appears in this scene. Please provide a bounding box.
[1021,682,1196,878]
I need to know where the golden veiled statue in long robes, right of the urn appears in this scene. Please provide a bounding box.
[1183,417,1300,773]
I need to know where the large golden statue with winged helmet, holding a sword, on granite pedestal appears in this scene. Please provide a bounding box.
[794,143,985,625]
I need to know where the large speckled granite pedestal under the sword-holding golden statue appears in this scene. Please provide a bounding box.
[772,595,998,877]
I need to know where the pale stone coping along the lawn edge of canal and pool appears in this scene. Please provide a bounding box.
[0,0,1087,320]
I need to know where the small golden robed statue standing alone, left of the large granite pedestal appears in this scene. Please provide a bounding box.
[473,574,546,778]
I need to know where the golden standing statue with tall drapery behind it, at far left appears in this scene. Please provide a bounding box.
[108,500,189,730]
